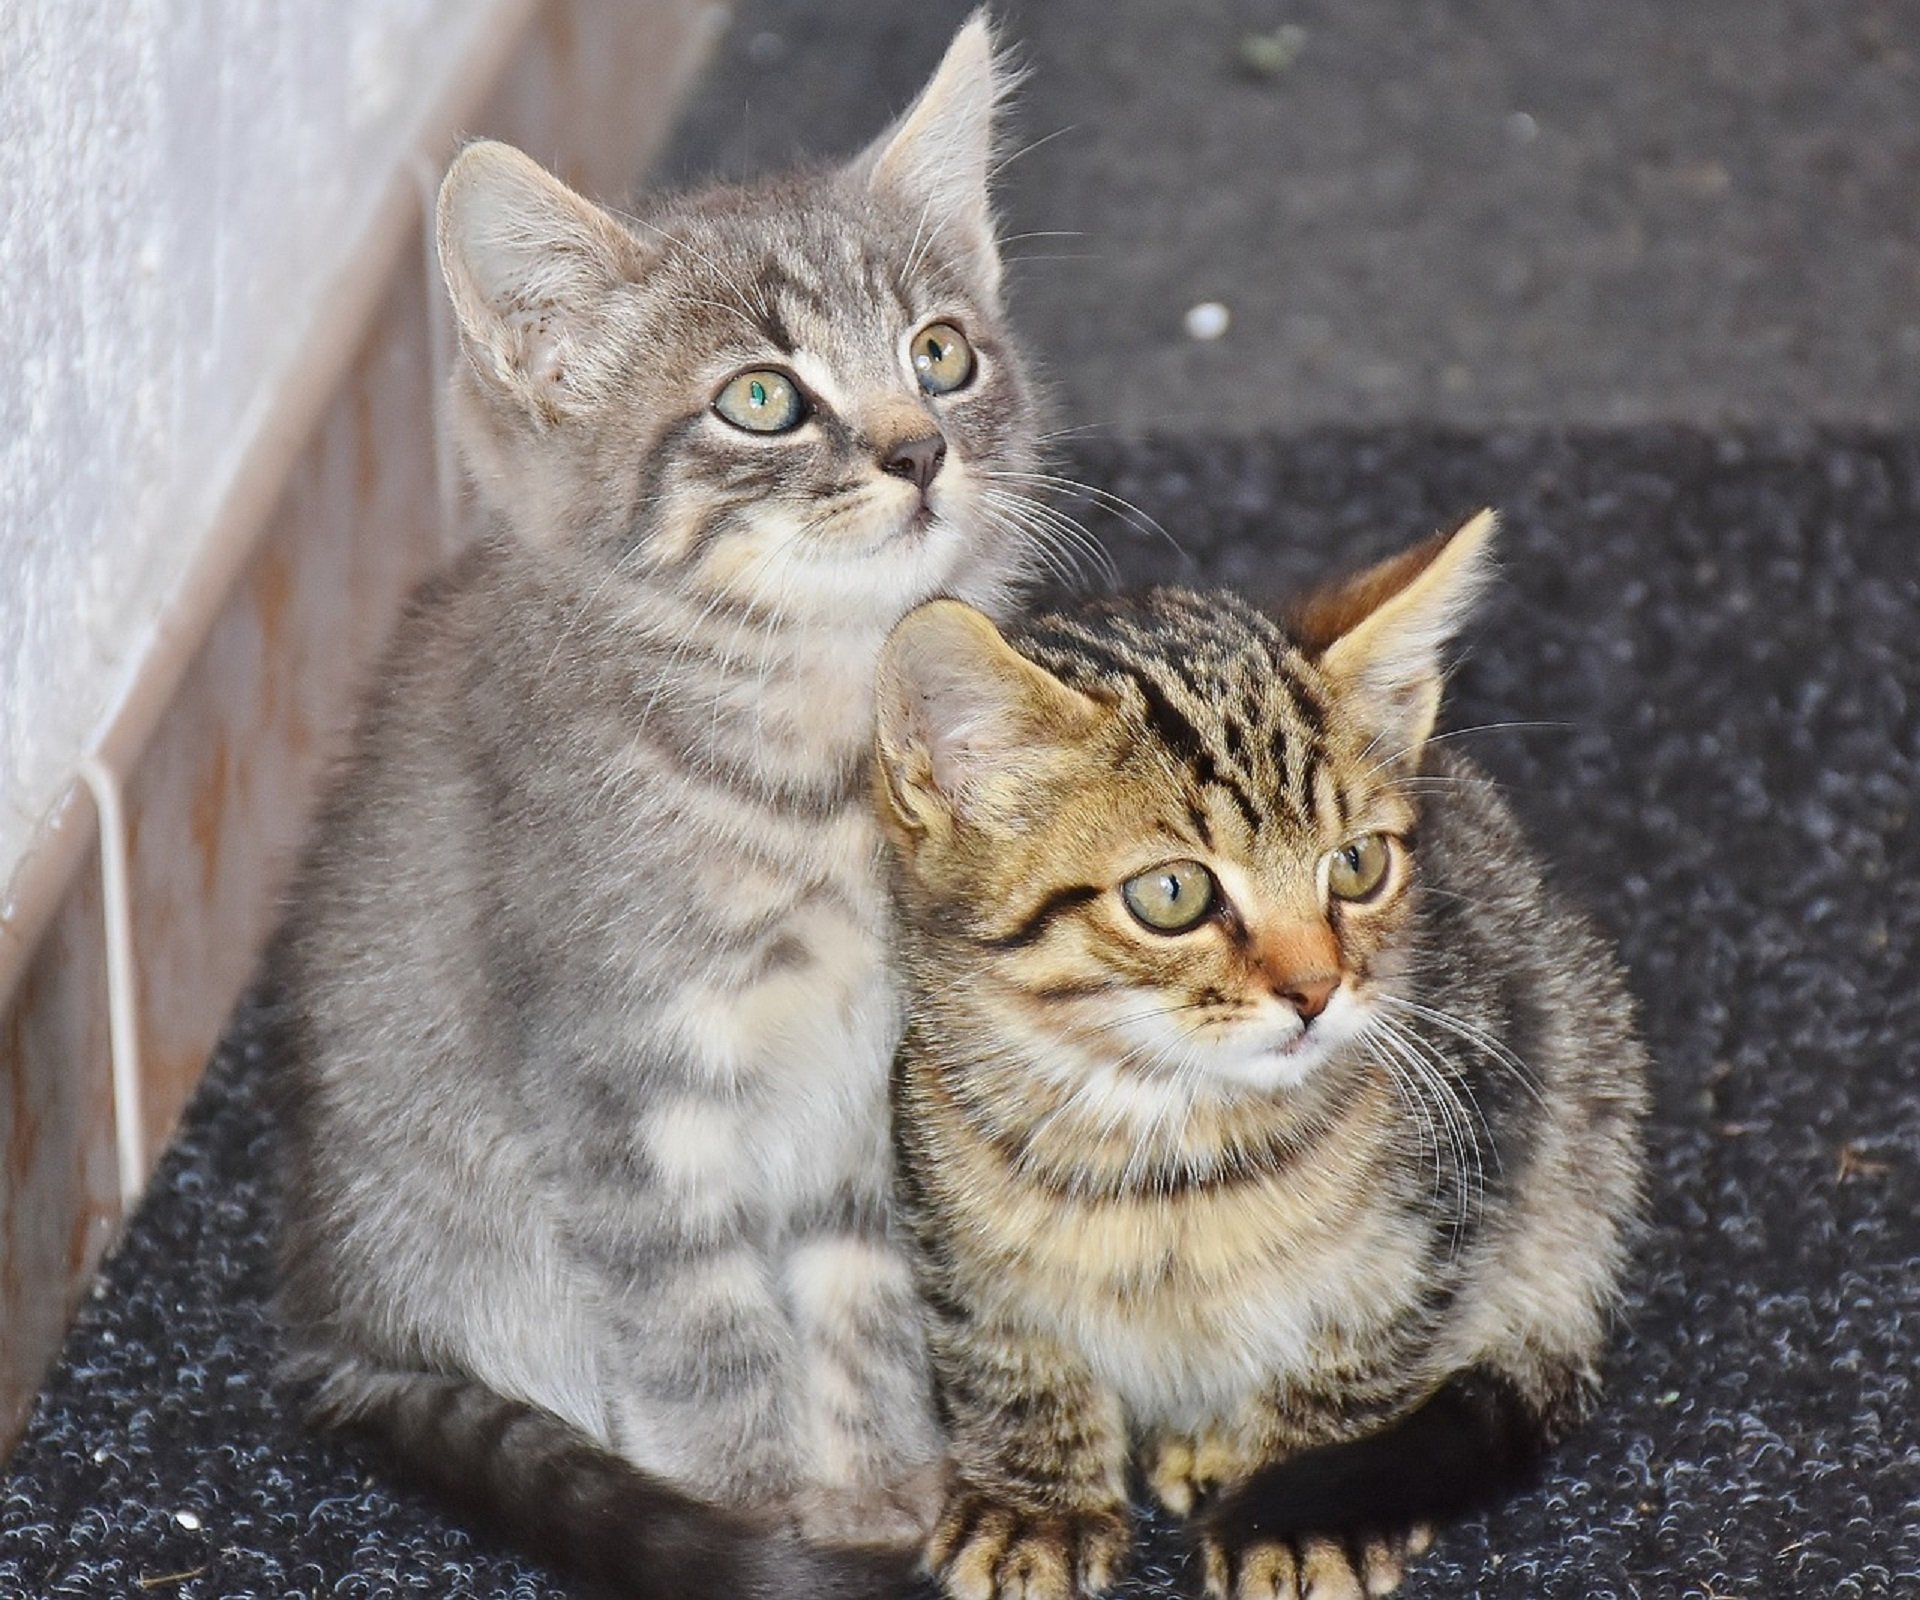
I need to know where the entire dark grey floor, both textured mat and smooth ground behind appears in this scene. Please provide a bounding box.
[0,0,1920,1600]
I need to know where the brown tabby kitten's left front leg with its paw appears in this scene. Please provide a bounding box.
[927,1321,1131,1600]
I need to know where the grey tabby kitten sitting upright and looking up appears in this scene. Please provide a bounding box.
[269,17,1041,1594]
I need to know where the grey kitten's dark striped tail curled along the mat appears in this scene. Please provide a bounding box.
[315,1371,918,1600]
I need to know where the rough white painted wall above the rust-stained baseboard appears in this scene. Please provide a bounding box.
[0,0,526,909]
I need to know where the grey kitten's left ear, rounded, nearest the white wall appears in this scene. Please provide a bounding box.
[436,140,645,409]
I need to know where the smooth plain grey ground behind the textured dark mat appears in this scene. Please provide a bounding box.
[664,0,1920,432]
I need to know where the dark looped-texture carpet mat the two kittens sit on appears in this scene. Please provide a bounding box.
[0,428,1920,1600]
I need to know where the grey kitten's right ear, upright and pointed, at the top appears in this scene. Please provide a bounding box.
[852,12,1016,294]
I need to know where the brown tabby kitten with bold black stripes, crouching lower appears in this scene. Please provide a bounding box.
[876,513,1644,1600]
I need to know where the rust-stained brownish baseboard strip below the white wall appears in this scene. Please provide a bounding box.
[0,0,726,1452]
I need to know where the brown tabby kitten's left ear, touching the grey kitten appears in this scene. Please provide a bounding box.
[874,599,1108,836]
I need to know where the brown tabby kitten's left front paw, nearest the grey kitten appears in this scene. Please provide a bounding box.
[927,1489,1133,1600]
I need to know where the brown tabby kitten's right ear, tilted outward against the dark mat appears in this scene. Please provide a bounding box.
[1288,511,1498,753]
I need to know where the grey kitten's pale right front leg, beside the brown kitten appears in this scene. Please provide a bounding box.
[785,1204,945,1546]
